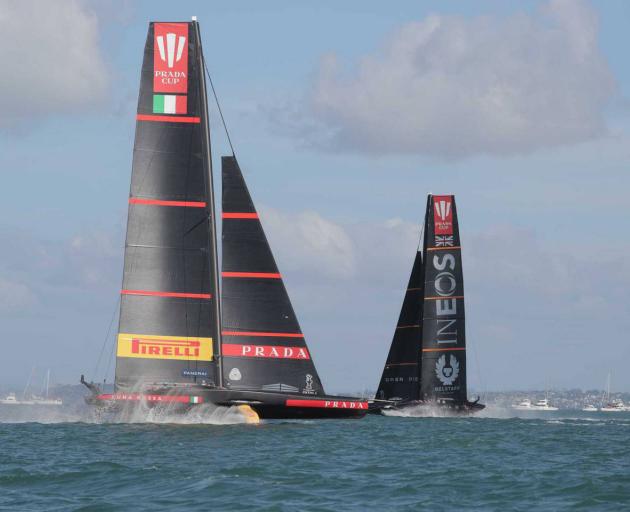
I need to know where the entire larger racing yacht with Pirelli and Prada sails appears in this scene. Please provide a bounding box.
[81,19,367,418]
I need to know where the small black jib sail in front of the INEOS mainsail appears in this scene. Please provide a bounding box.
[376,251,424,400]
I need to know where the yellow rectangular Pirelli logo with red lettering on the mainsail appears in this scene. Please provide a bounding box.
[116,333,212,361]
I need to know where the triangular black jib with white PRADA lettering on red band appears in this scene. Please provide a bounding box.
[221,156,324,395]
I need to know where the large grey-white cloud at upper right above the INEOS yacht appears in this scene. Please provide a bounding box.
[294,0,616,157]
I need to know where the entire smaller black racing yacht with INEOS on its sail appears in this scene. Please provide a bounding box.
[370,195,485,414]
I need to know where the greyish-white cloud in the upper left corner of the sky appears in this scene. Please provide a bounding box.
[0,0,108,128]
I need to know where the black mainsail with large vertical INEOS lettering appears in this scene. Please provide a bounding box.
[420,195,467,402]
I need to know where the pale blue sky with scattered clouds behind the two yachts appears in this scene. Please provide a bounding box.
[0,0,630,392]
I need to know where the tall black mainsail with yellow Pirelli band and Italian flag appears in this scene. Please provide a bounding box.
[116,22,218,391]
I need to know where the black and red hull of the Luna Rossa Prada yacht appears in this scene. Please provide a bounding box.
[86,387,368,419]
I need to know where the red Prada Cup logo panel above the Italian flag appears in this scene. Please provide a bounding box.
[153,23,188,93]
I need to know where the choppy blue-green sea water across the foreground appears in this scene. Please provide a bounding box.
[0,409,630,511]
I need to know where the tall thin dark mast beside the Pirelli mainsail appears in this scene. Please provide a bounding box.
[192,20,223,387]
